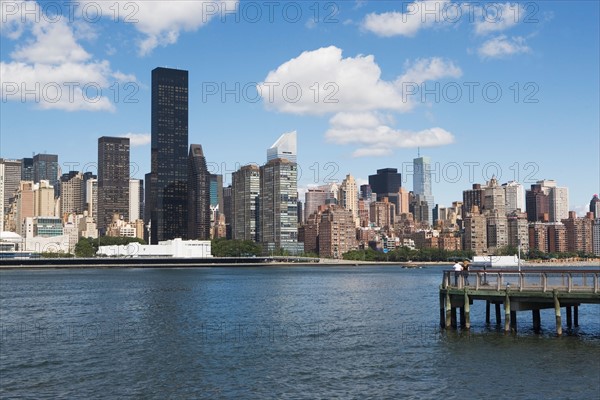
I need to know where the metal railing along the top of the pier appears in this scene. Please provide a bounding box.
[442,269,600,293]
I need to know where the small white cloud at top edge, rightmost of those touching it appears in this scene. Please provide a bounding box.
[472,3,527,35]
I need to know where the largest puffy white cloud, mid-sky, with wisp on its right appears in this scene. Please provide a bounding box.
[257,46,461,115]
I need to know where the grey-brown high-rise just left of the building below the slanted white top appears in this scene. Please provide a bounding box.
[231,164,260,241]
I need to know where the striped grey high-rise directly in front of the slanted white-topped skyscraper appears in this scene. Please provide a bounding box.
[259,158,298,252]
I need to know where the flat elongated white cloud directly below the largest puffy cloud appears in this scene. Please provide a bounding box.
[325,112,454,157]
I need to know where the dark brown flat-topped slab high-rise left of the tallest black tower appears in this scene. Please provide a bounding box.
[97,136,129,234]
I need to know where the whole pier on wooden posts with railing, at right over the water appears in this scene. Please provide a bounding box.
[440,269,600,336]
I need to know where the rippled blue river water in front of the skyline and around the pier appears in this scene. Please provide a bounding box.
[0,267,600,399]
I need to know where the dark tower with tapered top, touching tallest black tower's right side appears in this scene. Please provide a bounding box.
[187,144,210,240]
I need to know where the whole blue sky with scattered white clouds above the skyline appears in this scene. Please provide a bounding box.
[0,0,600,214]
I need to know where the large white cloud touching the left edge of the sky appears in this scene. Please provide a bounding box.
[0,1,135,111]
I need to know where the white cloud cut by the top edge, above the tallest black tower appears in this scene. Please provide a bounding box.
[80,0,239,55]
